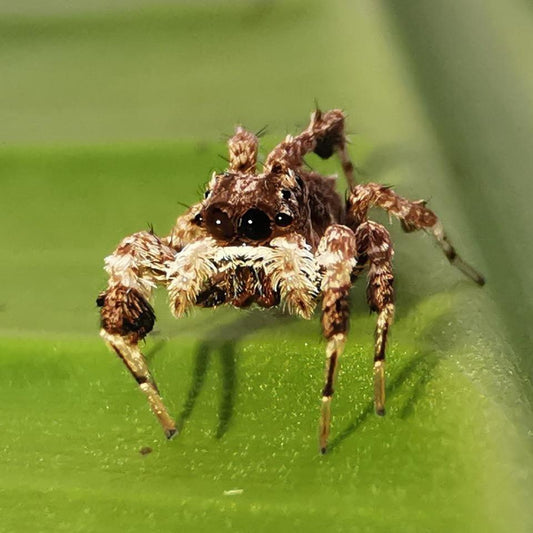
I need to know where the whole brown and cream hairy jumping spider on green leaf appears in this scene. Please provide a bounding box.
[97,110,484,453]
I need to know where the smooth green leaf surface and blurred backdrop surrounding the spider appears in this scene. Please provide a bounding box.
[0,0,533,532]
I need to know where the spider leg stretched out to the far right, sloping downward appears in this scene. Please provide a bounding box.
[346,183,485,285]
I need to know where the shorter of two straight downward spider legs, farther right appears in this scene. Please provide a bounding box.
[355,221,394,416]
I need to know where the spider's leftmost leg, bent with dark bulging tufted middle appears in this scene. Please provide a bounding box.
[97,232,176,439]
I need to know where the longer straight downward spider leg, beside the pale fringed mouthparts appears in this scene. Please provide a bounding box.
[317,224,356,453]
